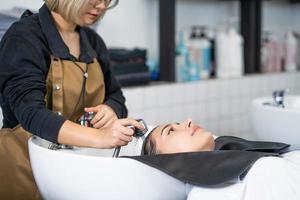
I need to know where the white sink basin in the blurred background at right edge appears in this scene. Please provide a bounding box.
[251,96,300,144]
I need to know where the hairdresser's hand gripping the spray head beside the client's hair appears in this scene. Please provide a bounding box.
[100,118,144,148]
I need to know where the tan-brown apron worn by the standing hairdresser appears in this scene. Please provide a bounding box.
[0,57,105,200]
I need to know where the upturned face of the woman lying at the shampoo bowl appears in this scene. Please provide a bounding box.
[145,119,215,154]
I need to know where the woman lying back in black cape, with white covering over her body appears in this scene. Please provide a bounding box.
[133,119,300,200]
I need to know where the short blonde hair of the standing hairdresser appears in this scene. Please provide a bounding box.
[44,0,87,23]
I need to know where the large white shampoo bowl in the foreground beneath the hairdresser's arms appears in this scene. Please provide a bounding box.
[28,137,187,200]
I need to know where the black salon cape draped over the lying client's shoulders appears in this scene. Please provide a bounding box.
[127,136,290,187]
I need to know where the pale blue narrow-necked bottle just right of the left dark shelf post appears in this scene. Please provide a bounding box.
[175,31,189,82]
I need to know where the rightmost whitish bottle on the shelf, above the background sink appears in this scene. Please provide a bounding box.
[283,32,298,72]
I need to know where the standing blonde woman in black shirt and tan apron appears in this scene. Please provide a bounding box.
[0,0,143,199]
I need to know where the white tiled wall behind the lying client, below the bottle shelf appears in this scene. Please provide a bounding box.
[123,72,300,139]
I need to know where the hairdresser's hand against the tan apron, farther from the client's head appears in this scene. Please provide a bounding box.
[84,104,118,129]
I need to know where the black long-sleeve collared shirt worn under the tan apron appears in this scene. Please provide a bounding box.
[0,5,127,142]
